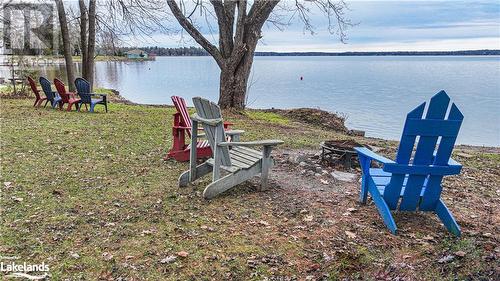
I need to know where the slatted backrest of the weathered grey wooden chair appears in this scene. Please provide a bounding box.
[193,97,231,166]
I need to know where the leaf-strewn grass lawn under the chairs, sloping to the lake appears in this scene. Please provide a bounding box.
[0,99,500,280]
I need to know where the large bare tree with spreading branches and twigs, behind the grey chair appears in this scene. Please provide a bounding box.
[167,0,351,109]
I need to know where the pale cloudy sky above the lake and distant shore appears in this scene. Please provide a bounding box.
[133,0,500,52]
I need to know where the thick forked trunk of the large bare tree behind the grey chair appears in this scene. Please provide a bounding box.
[167,0,280,110]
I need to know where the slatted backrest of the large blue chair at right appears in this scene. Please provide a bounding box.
[383,91,463,211]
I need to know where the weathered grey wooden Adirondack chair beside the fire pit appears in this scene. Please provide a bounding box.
[179,97,283,199]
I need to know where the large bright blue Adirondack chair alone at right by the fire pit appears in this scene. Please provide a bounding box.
[355,91,464,236]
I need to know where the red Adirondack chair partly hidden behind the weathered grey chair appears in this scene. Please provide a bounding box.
[164,96,232,162]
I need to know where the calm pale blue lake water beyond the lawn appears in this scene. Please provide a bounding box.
[2,56,500,146]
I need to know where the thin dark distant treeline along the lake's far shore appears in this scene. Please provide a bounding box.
[119,46,500,56]
